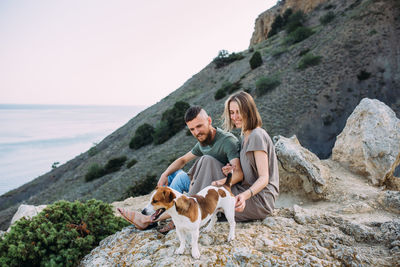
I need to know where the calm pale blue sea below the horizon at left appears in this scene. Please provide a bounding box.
[0,104,145,195]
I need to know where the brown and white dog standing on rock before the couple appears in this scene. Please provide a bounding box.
[145,173,236,259]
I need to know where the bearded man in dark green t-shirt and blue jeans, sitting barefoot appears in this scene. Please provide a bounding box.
[118,106,243,232]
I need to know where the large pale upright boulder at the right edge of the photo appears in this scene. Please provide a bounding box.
[332,98,400,190]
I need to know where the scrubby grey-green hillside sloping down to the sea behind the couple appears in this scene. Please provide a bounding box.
[0,0,400,229]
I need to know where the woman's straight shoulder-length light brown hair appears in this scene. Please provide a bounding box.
[222,92,262,133]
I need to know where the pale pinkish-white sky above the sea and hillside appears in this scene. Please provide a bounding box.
[0,0,276,105]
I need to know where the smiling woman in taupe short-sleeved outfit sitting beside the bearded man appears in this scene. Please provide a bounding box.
[214,92,279,221]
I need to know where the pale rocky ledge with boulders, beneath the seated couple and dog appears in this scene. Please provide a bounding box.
[80,99,400,266]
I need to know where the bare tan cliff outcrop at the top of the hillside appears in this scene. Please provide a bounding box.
[250,0,328,46]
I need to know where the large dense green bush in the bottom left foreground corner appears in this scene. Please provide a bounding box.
[0,200,129,266]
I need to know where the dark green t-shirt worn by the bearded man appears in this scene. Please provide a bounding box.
[192,128,240,165]
